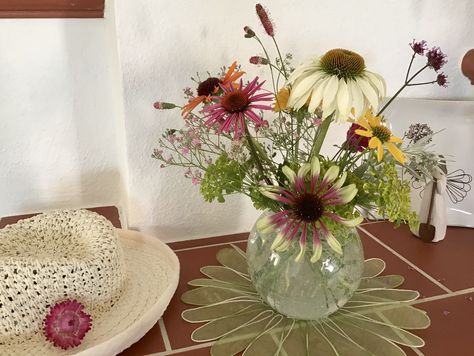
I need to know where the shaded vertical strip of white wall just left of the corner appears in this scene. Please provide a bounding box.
[63,14,126,214]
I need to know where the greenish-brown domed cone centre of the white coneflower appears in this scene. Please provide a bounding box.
[321,48,365,79]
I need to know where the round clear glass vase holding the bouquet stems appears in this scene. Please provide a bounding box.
[247,213,364,320]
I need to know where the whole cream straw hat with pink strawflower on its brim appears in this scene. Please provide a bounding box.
[0,210,179,356]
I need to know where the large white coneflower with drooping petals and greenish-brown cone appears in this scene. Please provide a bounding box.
[288,48,386,122]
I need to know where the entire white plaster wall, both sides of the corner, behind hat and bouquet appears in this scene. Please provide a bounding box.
[0,0,474,241]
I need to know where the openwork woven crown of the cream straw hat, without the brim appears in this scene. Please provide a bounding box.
[0,210,125,344]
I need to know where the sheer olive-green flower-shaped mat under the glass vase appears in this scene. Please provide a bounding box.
[182,246,430,356]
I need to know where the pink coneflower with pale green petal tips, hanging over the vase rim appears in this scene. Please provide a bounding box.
[257,157,363,263]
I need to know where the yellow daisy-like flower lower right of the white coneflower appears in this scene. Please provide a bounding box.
[355,110,406,164]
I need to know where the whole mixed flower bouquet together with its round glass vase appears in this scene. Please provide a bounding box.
[153,4,454,319]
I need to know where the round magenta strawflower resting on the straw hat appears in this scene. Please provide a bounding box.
[43,300,92,350]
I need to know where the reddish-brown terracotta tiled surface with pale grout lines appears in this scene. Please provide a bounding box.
[0,207,474,356]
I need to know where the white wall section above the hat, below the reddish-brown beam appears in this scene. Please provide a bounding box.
[0,2,125,216]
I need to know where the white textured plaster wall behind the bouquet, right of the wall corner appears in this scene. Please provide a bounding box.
[116,0,474,239]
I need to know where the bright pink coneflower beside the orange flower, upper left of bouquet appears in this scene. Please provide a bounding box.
[203,77,273,139]
